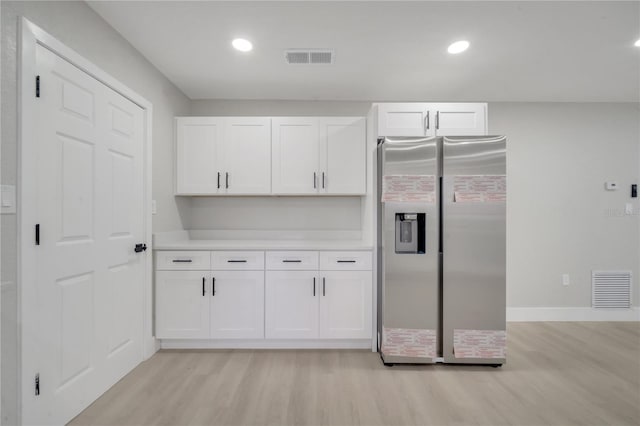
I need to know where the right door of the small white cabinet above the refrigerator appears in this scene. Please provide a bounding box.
[430,103,487,136]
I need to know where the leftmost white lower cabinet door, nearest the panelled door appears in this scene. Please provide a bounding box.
[155,271,211,339]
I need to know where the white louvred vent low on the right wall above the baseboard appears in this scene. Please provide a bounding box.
[591,271,631,309]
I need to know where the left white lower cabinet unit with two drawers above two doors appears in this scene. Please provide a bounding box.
[155,251,264,339]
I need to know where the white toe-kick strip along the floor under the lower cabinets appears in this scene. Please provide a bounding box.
[160,339,371,349]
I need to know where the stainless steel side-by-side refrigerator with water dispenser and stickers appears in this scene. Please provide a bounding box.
[377,136,506,366]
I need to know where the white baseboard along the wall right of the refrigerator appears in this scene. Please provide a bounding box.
[507,307,640,322]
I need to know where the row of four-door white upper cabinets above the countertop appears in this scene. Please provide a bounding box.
[176,117,366,195]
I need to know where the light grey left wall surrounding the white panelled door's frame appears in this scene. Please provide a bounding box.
[1,0,190,424]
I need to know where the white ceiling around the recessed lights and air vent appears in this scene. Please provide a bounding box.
[89,1,640,102]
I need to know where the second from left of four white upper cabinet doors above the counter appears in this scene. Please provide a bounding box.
[220,117,271,194]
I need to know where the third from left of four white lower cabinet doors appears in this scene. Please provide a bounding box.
[265,271,321,339]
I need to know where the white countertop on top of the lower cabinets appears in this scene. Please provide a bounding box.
[153,232,373,250]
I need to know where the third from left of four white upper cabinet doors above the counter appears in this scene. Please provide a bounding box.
[271,117,320,195]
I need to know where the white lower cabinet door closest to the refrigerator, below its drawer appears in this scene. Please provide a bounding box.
[320,271,372,339]
